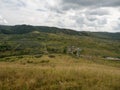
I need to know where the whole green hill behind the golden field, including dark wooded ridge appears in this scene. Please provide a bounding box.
[0,25,120,57]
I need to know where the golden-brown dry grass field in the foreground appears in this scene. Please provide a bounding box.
[0,55,120,90]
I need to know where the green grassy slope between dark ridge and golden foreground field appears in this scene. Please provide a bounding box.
[0,33,120,57]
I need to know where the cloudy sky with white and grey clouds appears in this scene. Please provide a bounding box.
[0,0,120,32]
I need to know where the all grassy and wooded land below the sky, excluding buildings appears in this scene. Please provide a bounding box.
[0,25,120,90]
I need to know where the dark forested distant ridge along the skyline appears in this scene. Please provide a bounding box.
[0,25,120,40]
